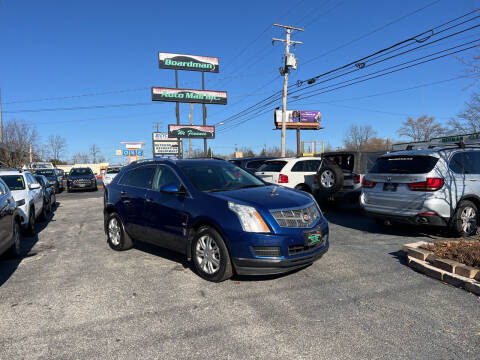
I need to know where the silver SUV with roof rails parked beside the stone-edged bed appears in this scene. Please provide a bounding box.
[360,144,480,236]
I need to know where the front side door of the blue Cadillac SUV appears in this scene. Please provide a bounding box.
[144,165,188,253]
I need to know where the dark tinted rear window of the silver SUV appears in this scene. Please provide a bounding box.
[370,155,438,174]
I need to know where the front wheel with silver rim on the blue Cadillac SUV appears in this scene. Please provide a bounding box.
[192,226,233,282]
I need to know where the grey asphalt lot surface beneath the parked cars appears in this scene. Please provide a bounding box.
[0,190,480,359]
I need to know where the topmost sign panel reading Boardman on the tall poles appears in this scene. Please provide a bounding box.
[158,53,218,72]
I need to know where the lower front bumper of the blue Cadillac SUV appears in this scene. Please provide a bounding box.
[232,239,329,275]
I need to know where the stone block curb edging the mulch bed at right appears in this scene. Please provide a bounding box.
[402,241,480,296]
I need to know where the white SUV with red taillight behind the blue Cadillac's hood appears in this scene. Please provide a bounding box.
[255,157,322,193]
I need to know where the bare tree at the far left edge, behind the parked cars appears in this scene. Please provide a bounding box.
[1,119,40,168]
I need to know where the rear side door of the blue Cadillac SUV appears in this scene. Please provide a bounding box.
[118,165,156,240]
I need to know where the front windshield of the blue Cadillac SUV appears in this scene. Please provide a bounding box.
[181,163,265,192]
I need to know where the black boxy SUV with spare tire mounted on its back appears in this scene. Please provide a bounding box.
[313,150,385,202]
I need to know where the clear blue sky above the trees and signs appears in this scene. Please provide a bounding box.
[0,0,480,162]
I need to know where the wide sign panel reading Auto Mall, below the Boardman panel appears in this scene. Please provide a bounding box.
[152,87,227,105]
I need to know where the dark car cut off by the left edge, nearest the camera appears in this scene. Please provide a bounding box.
[0,179,22,257]
